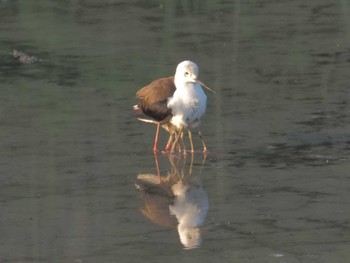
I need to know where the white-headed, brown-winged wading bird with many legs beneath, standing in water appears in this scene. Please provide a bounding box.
[134,60,215,153]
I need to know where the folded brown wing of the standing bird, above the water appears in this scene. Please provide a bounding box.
[136,77,176,121]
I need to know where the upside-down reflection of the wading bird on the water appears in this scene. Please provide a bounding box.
[135,155,209,249]
